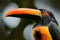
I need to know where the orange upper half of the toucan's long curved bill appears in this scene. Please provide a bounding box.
[5,8,41,17]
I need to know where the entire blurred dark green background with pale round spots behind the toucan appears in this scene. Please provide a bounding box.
[0,0,60,40]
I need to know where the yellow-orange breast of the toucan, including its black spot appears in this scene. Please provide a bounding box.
[33,26,53,40]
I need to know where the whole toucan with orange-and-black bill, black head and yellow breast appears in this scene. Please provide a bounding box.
[5,8,60,40]
